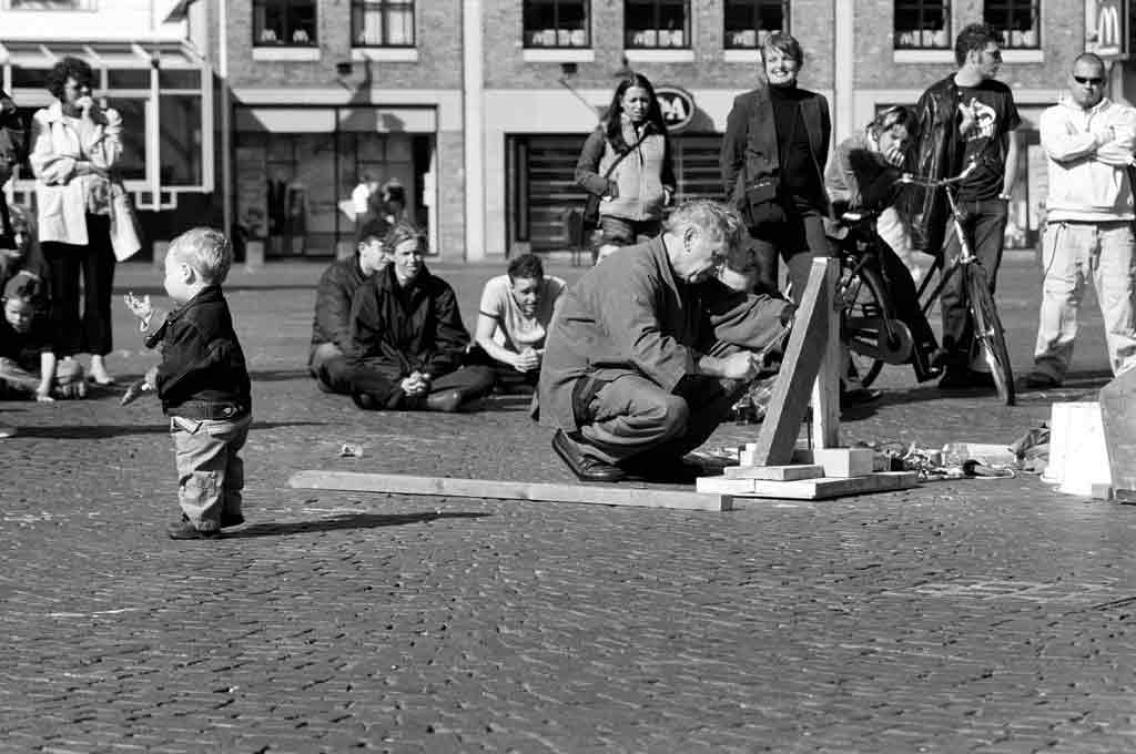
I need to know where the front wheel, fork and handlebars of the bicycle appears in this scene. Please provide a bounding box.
[896,160,1017,405]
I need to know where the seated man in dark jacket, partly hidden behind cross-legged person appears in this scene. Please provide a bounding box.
[308,235,391,395]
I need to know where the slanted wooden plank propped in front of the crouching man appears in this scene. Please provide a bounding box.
[753,259,834,466]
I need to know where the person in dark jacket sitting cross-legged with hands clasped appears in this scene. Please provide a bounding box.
[348,221,493,412]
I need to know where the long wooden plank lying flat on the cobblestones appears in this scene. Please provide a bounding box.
[289,470,730,511]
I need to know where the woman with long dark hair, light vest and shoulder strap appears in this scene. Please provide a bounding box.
[576,74,675,256]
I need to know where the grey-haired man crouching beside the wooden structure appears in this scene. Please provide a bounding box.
[538,201,793,481]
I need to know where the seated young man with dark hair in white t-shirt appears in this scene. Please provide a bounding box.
[468,253,565,395]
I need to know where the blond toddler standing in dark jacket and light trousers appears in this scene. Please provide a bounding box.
[127,228,252,539]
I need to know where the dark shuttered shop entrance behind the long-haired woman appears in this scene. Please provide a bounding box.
[506,134,721,251]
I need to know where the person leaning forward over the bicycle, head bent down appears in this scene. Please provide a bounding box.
[825,106,943,382]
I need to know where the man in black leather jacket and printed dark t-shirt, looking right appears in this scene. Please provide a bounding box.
[903,24,1021,388]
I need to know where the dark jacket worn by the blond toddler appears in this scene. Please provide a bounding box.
[145,285,252,419]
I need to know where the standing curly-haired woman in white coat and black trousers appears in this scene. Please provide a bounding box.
[30,57,123,385]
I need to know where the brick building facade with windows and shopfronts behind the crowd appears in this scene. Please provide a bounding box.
[0,0,1128,260]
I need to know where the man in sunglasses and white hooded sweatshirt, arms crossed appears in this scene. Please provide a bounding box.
[1026,52,1136,388]
